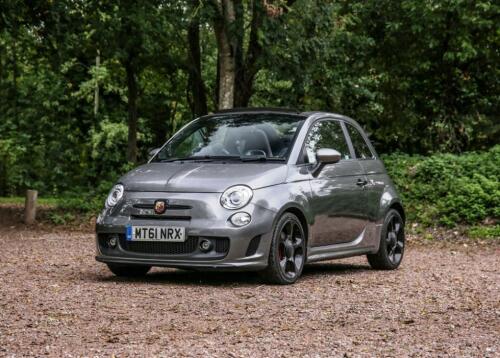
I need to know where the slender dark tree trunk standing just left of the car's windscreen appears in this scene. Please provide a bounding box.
[125,58,138,163]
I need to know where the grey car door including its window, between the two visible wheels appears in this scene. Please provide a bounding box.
[304,119,367,246]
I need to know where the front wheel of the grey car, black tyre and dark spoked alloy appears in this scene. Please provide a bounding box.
[261,213,306,285]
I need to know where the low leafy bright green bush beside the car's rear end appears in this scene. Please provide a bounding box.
[383,145,500,227]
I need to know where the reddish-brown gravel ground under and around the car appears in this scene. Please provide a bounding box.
[0,220,500,357]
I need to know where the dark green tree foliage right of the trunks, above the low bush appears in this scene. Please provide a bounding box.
[252,0,500,154]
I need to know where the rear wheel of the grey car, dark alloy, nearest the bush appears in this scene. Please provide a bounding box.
[367,209,405,270]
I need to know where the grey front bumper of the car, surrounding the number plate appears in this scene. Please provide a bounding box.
[96,192,275,270]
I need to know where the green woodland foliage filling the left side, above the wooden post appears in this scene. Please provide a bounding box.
[0,0,189,196]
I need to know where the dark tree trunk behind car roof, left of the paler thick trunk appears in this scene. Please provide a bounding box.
[188,0,208,117]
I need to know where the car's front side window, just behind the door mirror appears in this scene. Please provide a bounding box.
[305,120,351,163]
